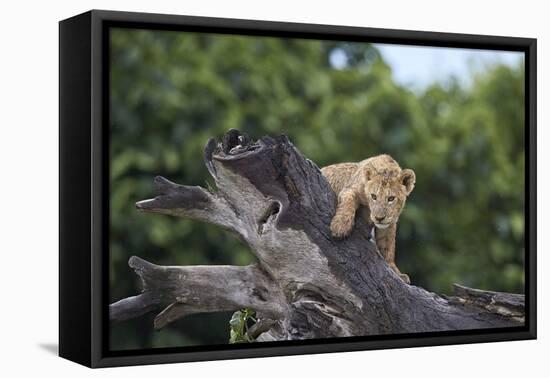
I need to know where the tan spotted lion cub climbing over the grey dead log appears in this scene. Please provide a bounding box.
[321,155,416,283]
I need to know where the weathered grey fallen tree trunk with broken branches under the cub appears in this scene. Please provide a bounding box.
[110,130,524,340]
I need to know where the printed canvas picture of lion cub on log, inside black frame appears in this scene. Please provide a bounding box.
[108,27,526,352]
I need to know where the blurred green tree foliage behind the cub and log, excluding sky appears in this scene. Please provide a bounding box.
[109,29,525,350]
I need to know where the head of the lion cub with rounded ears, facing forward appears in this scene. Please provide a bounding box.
[364,168,416,229]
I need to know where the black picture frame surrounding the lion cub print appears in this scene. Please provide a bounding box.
[59,10,537,367]
